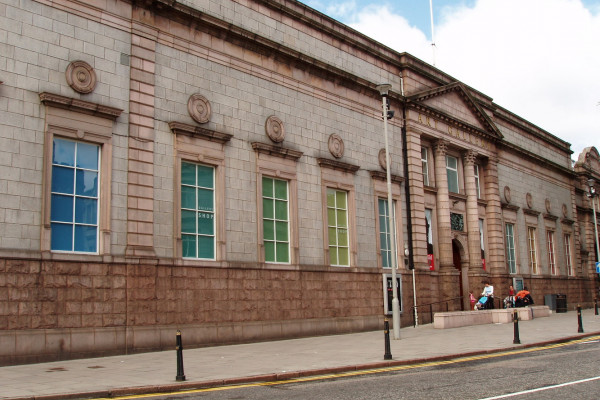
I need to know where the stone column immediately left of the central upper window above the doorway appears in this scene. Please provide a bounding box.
[434,140,454,270]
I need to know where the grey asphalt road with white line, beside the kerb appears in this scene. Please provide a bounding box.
[123,341,600,400]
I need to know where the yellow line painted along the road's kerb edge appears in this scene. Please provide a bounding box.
[96,336,600,400]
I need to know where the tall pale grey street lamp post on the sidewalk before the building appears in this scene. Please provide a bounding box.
[377,83,400,339]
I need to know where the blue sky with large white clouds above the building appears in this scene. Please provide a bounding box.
[303,0,600,158]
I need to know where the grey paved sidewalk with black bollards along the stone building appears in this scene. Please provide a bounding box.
[0,309,600,400]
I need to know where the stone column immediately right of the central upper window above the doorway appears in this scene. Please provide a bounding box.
[463,150,482,273]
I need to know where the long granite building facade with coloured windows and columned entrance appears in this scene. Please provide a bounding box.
[0,0,600,364]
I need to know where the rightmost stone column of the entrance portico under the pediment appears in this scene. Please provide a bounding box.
[484,158,508,275]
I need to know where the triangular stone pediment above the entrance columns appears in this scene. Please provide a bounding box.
[407,82,502,139]
